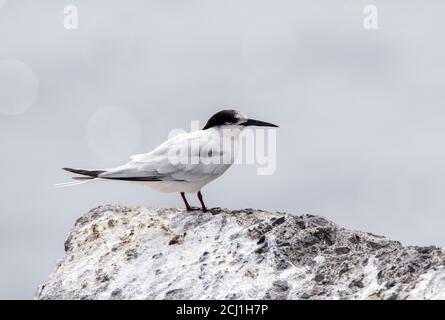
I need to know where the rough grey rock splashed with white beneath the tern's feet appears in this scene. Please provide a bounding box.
[36,205,445,299]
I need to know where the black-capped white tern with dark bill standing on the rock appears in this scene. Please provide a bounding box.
[62,109,278,212]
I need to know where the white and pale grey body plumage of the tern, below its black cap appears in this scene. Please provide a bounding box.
[97,128,240,193]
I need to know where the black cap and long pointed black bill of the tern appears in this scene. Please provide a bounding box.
[203,110,278,130]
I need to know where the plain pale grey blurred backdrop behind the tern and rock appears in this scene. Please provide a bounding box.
[0,0,445,298]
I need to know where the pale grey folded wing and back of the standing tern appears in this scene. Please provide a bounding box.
[99,131,230,182]
